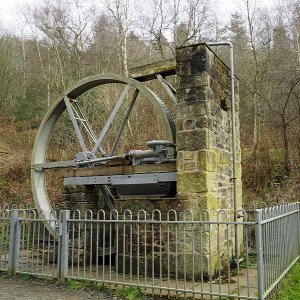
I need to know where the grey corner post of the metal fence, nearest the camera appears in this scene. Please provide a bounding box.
[255,209,264,300]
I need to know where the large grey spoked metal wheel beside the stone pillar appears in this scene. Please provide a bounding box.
[31,74,175,230]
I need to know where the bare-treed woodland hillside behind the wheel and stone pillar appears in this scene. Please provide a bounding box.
[0,0,300,206]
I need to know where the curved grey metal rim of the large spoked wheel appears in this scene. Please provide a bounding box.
[31,74,175,230]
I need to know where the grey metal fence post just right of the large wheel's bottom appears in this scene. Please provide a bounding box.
[58,210,70,282]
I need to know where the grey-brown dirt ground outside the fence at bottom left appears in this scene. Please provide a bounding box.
[0,278,117,300]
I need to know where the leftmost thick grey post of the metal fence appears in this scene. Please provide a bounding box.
[8,209,20,275]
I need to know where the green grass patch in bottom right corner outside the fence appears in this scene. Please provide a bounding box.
[271,261,300,300]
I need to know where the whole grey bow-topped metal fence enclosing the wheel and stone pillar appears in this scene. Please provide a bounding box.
[0,203,300,299]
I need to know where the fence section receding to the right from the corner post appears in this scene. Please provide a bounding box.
[256,203,300,298]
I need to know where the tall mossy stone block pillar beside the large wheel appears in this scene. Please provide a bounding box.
[176,44,242,272]
